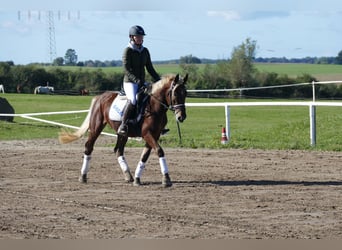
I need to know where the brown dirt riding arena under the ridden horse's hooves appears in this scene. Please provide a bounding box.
[0,138,342,239]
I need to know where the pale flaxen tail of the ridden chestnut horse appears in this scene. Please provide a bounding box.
[58,97,97,144]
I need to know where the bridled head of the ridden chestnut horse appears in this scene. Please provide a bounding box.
[166,74,188,122]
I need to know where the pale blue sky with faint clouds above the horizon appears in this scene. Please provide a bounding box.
[0,0,342,64]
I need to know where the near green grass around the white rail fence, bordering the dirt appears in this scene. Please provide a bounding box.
[0,94,342,151]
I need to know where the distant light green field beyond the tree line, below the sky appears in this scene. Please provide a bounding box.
[46,63,342,81]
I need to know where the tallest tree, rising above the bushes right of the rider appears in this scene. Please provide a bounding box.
[229,38,256,88]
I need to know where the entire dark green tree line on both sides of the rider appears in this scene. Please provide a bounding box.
[0,38,342,98]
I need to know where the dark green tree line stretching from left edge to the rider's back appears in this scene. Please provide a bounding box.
[0,62,123,94]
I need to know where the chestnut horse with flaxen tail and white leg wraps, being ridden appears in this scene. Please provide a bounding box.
[59,74,188,187]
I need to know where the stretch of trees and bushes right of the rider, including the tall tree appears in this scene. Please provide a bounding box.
[180,38,342,99]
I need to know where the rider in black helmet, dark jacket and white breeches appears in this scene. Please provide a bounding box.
[118,25,160,135]
